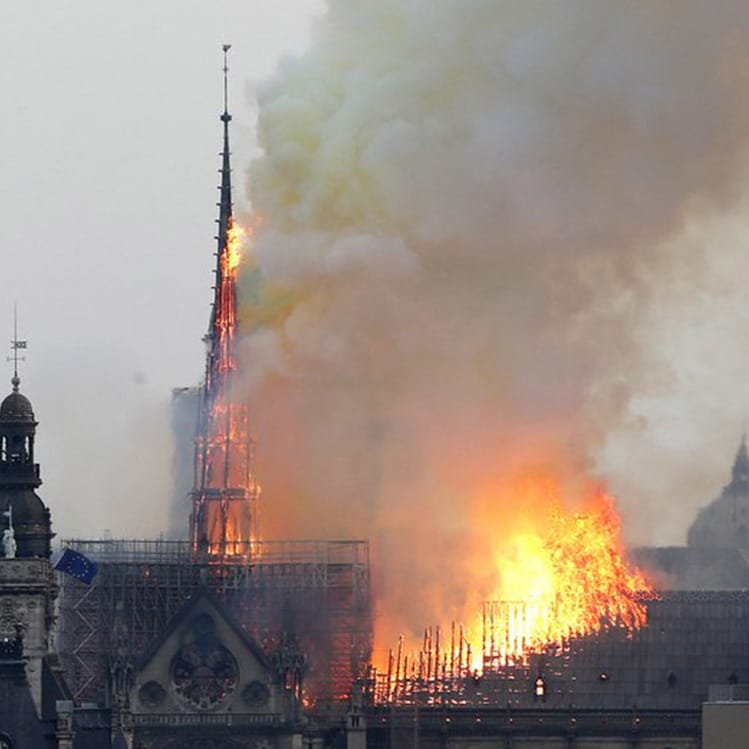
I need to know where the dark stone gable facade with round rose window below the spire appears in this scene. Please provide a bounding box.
[130,591,301,749]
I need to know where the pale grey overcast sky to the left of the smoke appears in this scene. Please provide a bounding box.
[0,0,322,536]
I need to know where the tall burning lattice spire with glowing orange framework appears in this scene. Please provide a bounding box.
[190,44,260,561]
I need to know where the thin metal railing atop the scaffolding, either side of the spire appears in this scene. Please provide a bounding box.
[62,538,369,565]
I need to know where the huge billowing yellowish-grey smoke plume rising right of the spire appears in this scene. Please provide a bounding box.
[242,0,749,645]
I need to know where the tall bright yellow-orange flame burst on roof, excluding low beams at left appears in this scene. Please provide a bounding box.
[469,492,653,663]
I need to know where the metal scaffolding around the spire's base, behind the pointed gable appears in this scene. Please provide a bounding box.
[58,540,372,707]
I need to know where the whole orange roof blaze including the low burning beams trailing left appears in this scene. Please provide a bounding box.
[380,479,655,688]
